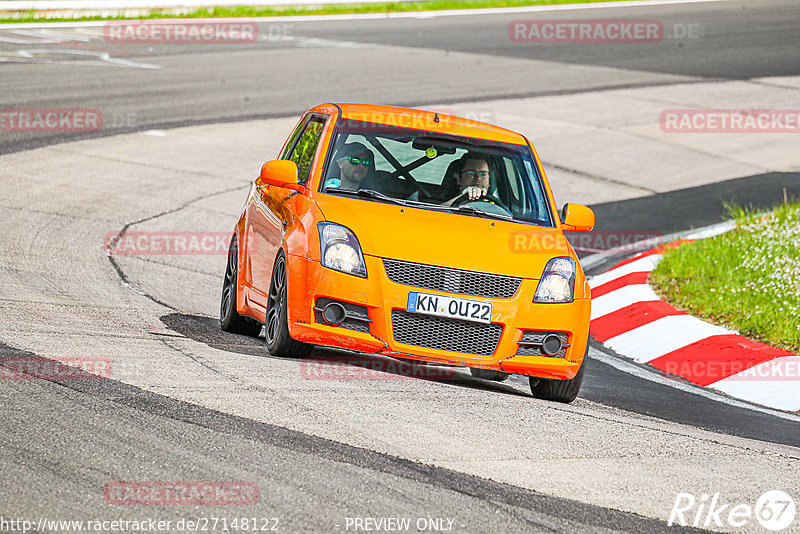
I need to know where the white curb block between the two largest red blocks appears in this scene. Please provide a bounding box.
[603,315,737,363]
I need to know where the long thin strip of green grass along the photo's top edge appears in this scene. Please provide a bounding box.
[0,0,636,23]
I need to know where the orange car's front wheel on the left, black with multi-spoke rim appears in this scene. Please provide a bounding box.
[265,251,314,358]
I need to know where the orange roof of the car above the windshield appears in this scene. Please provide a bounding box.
[310,103,527,145]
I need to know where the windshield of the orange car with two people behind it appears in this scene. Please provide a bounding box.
[320,119,554,227]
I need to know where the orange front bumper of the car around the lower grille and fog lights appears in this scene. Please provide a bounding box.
[287,256,591,379]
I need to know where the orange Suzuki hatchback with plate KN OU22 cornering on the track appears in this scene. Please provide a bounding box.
[220,104,594,402]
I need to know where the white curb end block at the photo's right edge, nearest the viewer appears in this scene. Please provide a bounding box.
[708,356,800,412]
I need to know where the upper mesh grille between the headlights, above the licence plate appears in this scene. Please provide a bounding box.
[383,258,522,299]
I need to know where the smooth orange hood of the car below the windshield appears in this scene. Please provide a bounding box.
[315,194,574,279]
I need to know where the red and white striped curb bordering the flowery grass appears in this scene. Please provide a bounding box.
[589,239,800,412]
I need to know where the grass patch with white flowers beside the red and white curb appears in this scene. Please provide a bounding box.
[650,201,800,352]
